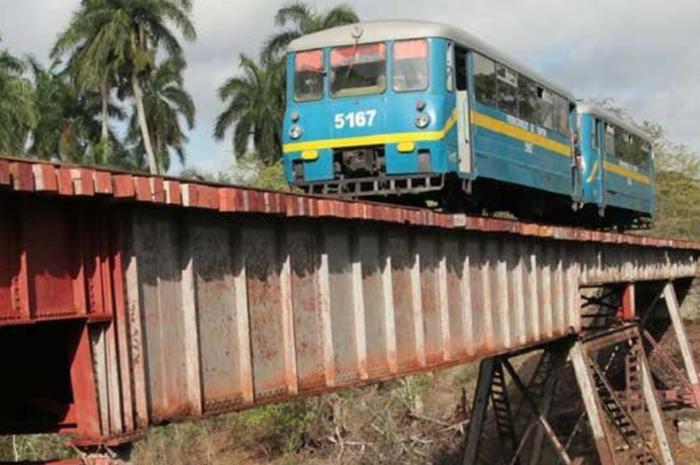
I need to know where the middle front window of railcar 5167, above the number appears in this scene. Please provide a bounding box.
[331,44,386,97]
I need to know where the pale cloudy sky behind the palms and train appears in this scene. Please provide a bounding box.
[0,0,700,172]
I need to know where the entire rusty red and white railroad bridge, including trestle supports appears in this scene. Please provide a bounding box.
[0,158,700,465]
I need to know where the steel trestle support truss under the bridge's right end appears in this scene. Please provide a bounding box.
[464,282,699,465]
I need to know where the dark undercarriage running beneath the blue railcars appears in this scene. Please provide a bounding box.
[292,146,652,232]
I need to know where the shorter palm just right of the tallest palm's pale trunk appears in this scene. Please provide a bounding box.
[129,58,195,171]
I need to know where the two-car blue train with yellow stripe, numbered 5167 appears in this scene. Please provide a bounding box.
[282,21,656,230]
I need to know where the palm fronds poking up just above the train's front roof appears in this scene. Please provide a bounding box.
[262,1,360,61]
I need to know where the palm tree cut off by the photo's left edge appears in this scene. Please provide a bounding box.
[0,37,36,153]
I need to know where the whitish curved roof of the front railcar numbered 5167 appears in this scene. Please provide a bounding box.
[289,20,576,102]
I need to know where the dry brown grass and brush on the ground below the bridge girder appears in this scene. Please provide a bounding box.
[135,366,476,465]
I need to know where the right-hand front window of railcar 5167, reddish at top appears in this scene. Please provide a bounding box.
[393,39,428,92]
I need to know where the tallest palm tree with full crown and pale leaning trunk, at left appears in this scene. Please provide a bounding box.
[54,0,196,173]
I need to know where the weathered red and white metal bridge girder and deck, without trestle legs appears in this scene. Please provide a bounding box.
[0,159,700,442]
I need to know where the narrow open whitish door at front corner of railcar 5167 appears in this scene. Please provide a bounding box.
[448,46,473,176]
